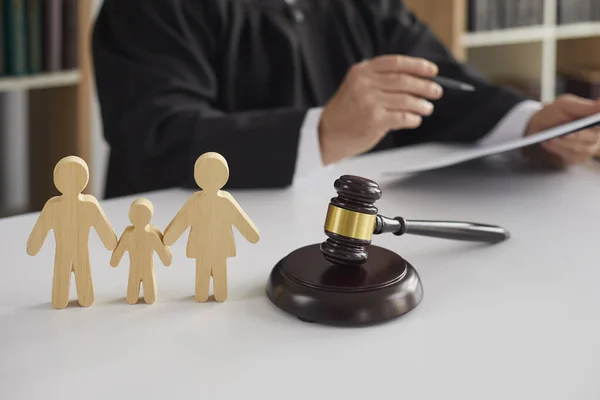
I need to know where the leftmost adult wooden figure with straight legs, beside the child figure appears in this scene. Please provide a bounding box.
[27,156,117,309]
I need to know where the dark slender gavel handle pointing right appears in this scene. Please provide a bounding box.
[373,215,510,243]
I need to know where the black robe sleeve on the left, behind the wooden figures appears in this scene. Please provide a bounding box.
[92,0,308,197]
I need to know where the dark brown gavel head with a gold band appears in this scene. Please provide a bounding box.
[321,175,381,265]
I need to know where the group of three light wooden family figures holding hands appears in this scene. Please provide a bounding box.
[27,152,259,309]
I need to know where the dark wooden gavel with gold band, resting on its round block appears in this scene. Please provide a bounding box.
[320,175,510,265]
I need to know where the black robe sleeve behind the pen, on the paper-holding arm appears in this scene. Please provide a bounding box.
[363,0,525,145]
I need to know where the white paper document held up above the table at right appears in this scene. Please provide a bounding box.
[385,113,600,175]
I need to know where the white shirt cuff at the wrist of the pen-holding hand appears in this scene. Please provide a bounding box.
[294,108,324,181]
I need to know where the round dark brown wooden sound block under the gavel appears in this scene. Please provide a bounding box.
[267,244,423,326]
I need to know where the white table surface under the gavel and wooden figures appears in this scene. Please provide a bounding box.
[0,153,600,400]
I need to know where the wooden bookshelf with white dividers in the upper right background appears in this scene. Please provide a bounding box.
[405,0,600,156]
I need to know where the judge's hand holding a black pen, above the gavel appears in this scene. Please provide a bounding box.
[319,55,443,165]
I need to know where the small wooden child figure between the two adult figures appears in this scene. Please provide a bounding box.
[110,199,173,304]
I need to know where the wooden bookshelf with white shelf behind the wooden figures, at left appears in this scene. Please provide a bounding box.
[0,0,93,216]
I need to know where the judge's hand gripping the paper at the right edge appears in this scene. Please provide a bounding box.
[523,95,600,168]
